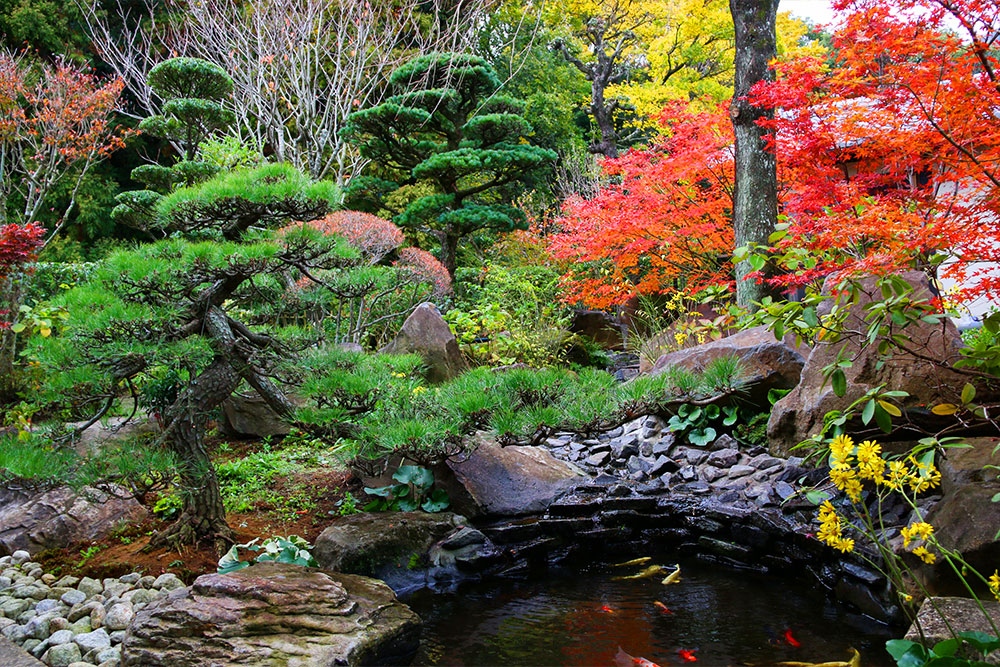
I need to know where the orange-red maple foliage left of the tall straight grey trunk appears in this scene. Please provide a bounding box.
[548,103,733,308]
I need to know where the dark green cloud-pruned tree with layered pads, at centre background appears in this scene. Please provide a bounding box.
[345,53,556,275]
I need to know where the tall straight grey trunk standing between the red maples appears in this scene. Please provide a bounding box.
[729,0,778,309]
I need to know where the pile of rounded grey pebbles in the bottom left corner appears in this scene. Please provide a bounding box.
[0,551,184,667]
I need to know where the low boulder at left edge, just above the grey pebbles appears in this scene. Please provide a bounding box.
[0,487,146,555]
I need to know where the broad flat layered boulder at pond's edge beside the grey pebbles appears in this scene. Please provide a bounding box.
[122,563,421,667]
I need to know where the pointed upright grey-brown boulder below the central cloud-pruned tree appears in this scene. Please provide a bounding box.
[380,303,468,383]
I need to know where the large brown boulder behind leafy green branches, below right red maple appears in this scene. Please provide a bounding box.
[767,271,963,456]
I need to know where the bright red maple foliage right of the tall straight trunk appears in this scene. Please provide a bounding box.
[754,0,1000,299]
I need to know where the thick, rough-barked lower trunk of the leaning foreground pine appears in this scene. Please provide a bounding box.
[151,354,240,551]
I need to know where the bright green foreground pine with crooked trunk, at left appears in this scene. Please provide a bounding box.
[34,164,340,545]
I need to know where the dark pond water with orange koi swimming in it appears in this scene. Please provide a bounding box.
[403,562,894,667]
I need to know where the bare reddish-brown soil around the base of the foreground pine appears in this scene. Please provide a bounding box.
[34,464,366,583]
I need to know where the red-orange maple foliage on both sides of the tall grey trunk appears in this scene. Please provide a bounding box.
[548,0,1000,308]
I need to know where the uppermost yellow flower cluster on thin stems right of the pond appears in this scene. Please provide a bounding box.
[830,435,941,502]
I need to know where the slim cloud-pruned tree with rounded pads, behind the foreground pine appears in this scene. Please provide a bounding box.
[112,58,235,235]
